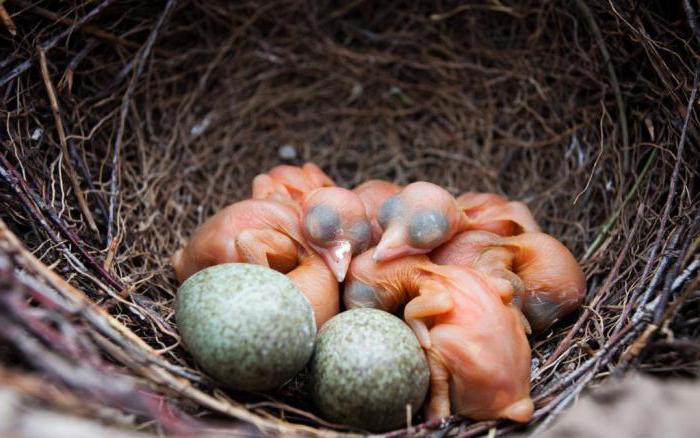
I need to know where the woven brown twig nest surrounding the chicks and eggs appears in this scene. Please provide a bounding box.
[0,0,700,436]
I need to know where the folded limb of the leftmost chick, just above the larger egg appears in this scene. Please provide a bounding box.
[236,229,298,273]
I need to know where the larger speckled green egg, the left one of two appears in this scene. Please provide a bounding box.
[175,263,316,391]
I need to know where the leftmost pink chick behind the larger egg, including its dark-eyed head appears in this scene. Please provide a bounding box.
[172,163,371,328]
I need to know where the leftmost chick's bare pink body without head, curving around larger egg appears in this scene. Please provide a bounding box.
[171,199,340,328]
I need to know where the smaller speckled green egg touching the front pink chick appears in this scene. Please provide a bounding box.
[310,309,430,432]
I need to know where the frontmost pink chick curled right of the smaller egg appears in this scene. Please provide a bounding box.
[345,250,533,422]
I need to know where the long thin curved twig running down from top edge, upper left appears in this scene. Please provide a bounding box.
[105,0,177,248]
